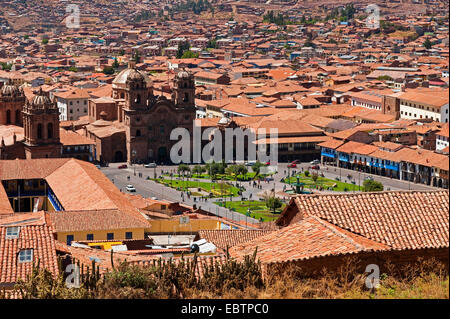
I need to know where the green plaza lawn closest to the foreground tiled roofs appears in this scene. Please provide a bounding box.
[216,200,286,222]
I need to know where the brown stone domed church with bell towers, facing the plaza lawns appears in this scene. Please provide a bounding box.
[84,62,196,163]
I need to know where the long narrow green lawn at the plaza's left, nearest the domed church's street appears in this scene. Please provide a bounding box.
[155,179,239,197]
